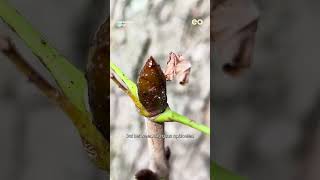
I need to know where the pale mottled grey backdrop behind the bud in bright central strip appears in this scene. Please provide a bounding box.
[110,0,210,180]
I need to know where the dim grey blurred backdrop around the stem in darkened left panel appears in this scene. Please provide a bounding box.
[0,0,109,180]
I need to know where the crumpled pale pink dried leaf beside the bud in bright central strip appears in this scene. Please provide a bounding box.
[164,52,191,85]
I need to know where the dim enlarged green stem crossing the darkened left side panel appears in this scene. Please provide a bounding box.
[0,0,110,171]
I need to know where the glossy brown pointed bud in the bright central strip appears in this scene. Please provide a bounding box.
[137,56,168,116]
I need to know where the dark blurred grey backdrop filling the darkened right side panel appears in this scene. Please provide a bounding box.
[211,0,320,180]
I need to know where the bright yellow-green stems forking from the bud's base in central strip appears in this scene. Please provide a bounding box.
[110,61,210,135]
